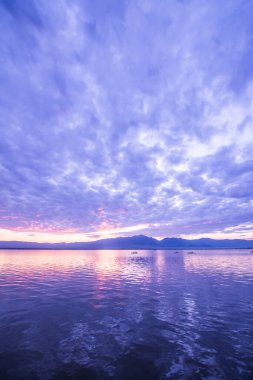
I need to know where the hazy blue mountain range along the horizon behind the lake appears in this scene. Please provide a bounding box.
[0,235,253,249]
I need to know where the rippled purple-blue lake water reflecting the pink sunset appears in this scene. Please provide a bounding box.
[0,250,253,380]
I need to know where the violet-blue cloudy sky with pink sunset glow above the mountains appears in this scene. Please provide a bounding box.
[0,0,253,242]
